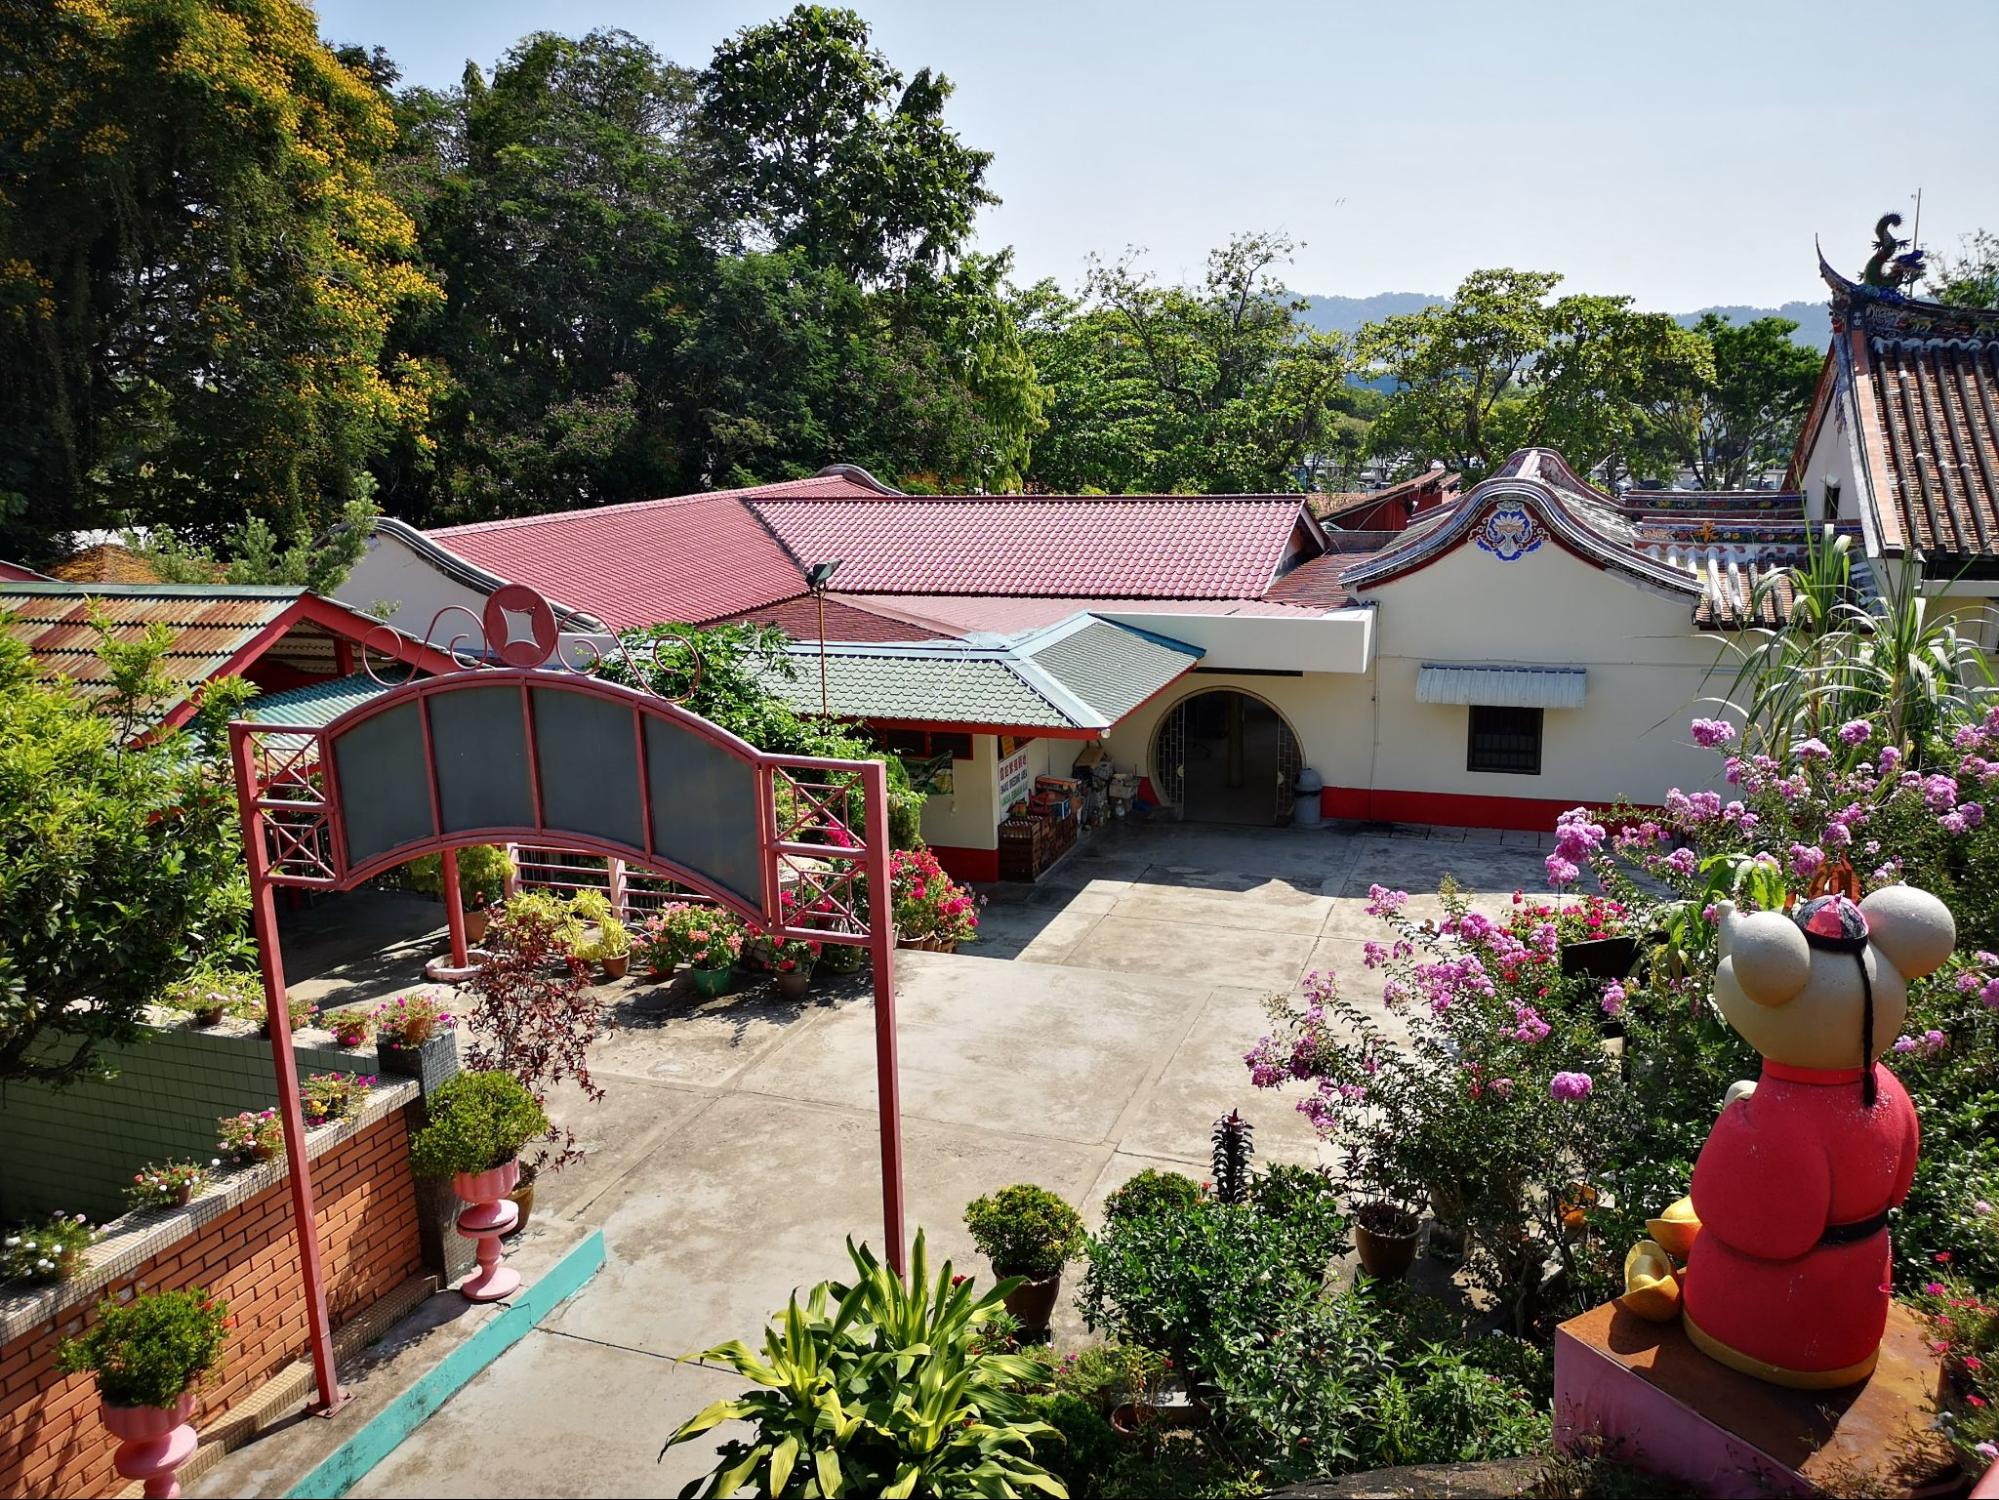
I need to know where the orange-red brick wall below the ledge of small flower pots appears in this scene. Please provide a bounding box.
[0,1106,422,1496]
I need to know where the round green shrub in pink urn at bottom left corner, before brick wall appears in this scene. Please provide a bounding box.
[56,1286,228,1494]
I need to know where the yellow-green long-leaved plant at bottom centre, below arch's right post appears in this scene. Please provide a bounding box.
[660,1230,1067,1500]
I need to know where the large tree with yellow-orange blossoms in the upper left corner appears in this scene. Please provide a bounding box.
[0,0,438,560]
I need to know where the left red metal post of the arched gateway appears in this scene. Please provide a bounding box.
[230,724,346,1416]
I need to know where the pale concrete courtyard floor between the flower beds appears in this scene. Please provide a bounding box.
[190,824,1547,1496]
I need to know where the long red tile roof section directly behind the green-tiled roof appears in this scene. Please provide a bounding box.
[750,496,1299,598]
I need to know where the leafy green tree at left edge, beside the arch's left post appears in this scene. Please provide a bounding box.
[0,632,250,1084]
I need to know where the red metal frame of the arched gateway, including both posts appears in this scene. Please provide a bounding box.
[230,666,904,1412]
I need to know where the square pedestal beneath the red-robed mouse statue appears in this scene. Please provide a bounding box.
[1555,1302,1955,1496]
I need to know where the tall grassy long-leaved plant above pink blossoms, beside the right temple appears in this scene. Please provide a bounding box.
[1723,526,1995,760]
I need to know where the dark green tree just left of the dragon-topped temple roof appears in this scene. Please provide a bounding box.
[1645,312,1823,490]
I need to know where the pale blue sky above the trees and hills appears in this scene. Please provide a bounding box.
[318,0,1999,312]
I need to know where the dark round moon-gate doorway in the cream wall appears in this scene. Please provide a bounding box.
[1153,688,1299,826]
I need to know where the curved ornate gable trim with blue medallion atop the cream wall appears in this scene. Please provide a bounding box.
[1343,448,1701,600]
